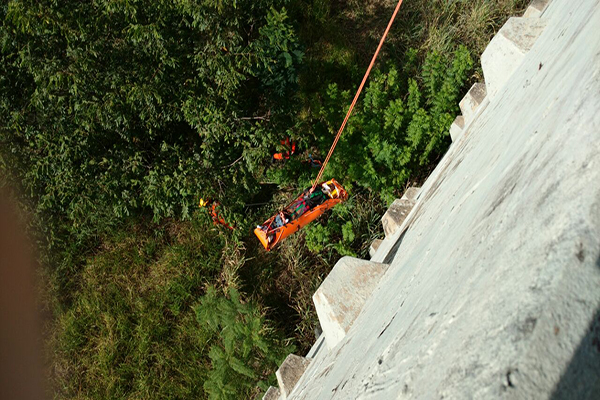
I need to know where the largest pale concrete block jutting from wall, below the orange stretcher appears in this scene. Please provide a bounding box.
[313,257,388,349]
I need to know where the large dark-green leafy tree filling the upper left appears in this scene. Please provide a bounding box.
[0,0,302,244]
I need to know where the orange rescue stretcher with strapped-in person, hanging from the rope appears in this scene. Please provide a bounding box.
[254,179,348,251]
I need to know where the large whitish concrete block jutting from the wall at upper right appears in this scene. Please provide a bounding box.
[481,17,547,98]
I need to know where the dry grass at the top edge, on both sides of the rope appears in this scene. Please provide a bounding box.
[303,0,529,83]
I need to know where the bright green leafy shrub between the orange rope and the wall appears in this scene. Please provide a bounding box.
[320,47,473,202]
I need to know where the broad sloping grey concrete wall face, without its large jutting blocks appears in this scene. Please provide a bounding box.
[291,0,600,400]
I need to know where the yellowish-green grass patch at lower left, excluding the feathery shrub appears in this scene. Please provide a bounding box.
[48,223,221,398]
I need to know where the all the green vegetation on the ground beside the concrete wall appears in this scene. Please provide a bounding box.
[0,0,526,399]
